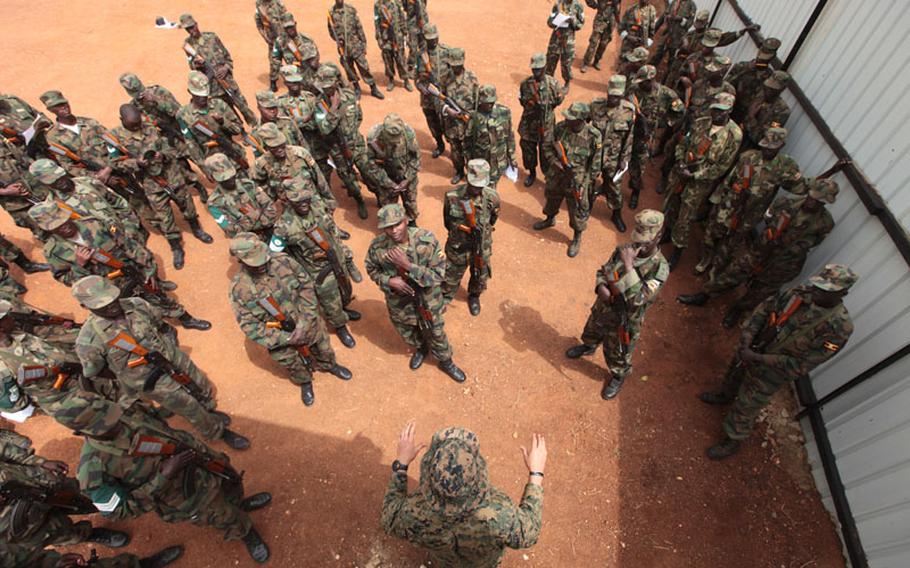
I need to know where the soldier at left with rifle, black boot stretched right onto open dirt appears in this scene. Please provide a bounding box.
[29,201,212,331]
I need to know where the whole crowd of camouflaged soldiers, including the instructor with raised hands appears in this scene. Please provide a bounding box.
[0,0,857,567]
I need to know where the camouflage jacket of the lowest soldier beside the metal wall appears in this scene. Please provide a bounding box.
[743,286,853,379]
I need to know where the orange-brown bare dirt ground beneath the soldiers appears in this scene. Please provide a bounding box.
[0,0,843,568]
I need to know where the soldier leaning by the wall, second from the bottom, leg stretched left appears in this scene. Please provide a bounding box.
[677,178,838,328]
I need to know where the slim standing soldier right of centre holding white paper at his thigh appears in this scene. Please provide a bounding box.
[588,75,635,233]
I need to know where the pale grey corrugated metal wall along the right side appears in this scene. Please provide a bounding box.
[698,0,910,568]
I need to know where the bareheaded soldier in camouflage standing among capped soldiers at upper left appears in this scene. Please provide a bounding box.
[111,104,212,270]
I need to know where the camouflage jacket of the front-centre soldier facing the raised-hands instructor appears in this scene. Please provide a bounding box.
[366,227,446,325]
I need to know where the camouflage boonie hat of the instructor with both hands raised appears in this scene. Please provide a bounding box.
[420,428,490,517]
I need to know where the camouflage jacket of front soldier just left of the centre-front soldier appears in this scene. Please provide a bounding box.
[229,252,321,350]
